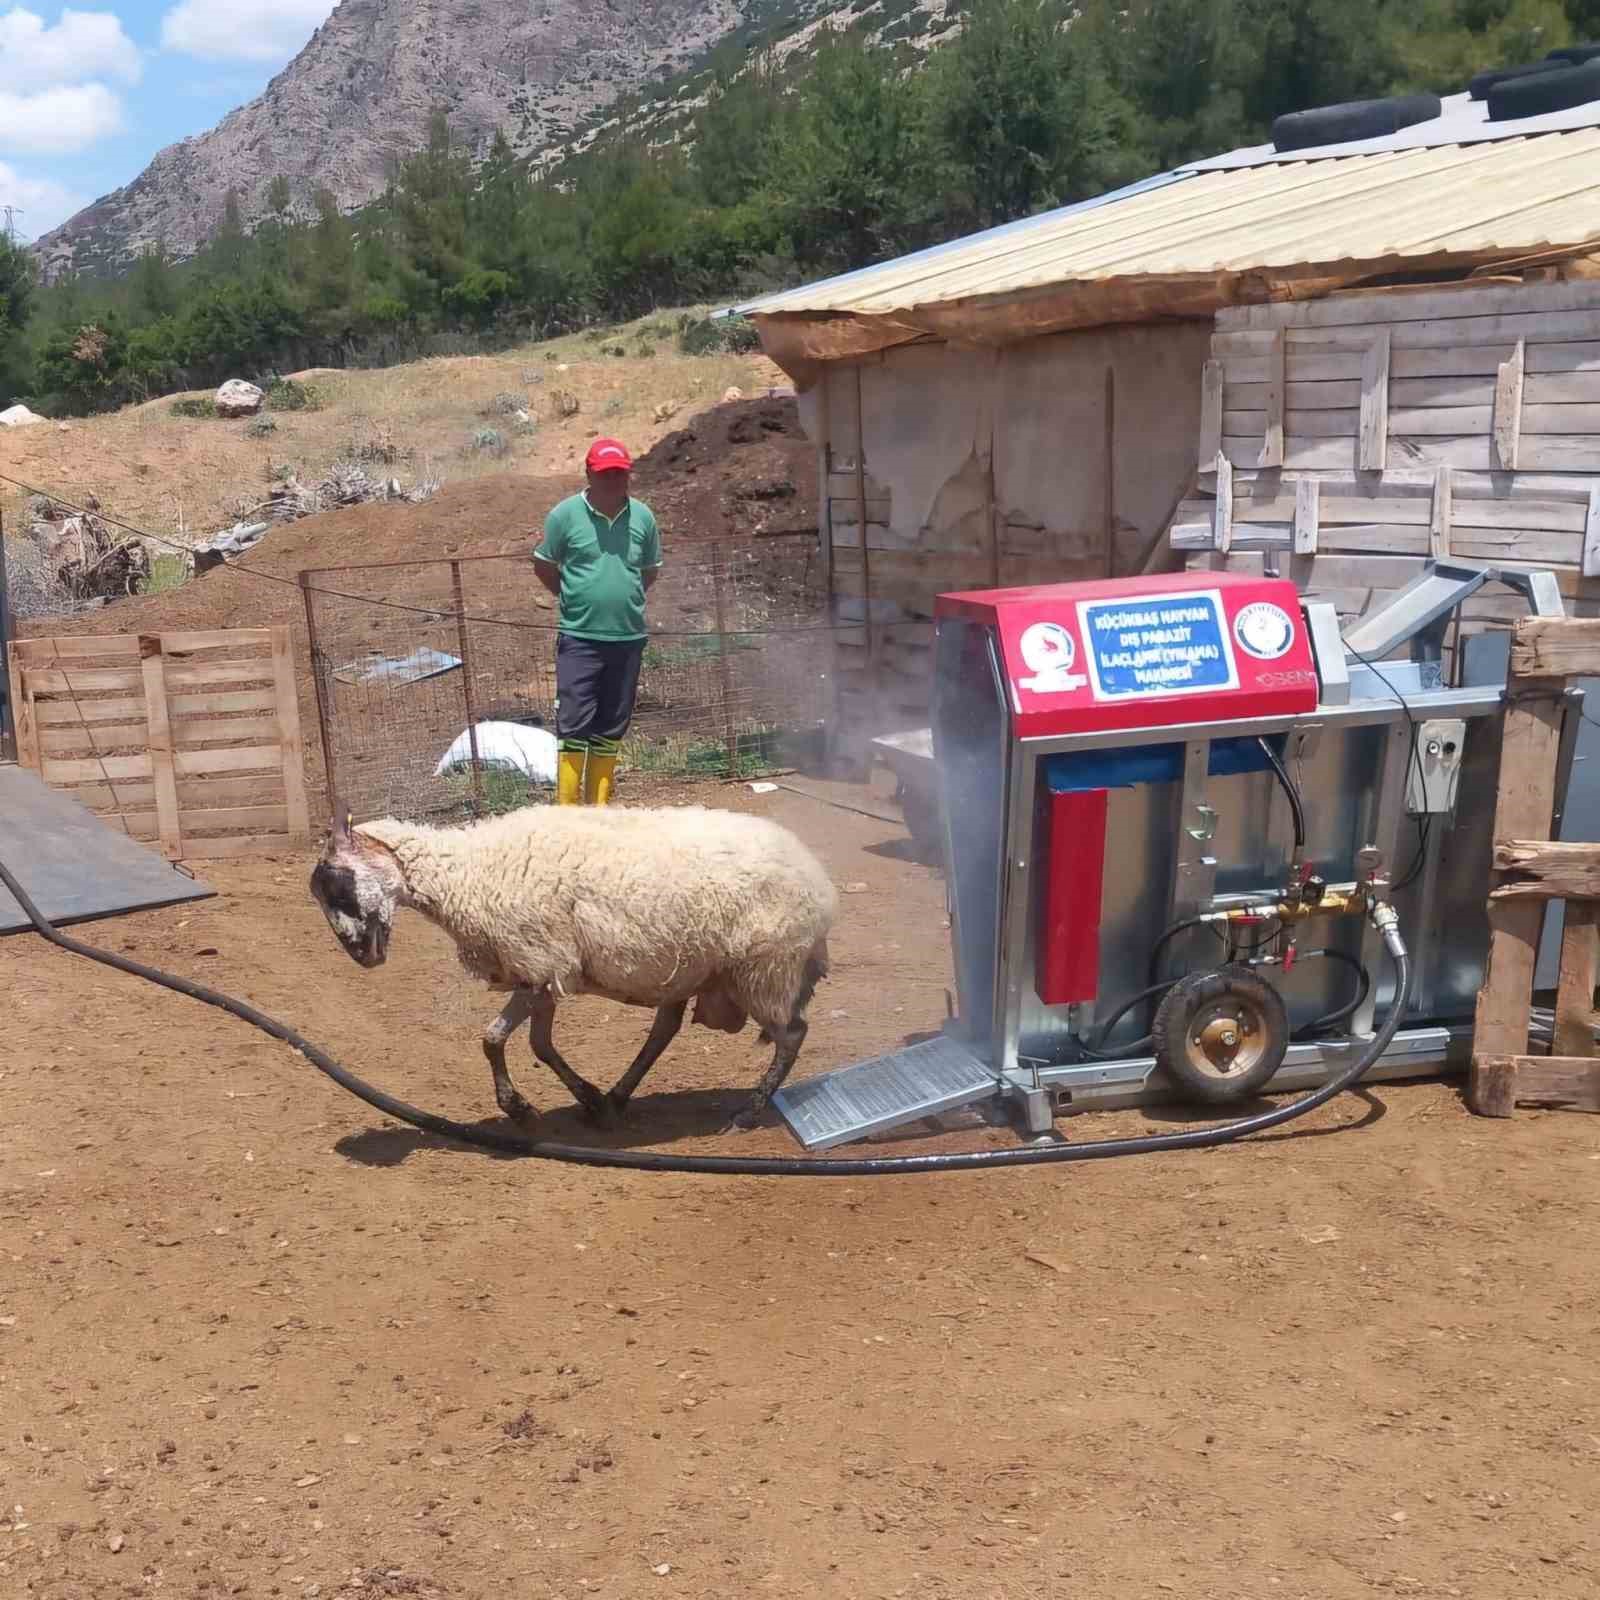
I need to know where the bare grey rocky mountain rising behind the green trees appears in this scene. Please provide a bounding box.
[35,0,755,277]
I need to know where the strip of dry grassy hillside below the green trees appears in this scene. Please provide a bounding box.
[0,312,787,542]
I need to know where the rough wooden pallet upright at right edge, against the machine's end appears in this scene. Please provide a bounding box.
[1467,618,1600,1117]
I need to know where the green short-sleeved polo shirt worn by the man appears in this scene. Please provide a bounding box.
[533,494,661,643]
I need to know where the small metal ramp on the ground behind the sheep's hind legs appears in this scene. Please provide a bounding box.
[773,1035,1000,1150]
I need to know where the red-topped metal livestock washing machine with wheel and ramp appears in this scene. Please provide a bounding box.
[774,563,1581,1149]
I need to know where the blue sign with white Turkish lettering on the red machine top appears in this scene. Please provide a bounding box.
[1078,589,1238,699]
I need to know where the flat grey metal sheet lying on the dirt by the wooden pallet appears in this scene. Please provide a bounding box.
[0,766,216,934]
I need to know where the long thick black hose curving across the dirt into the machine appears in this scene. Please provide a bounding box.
[0,861,1411,1178]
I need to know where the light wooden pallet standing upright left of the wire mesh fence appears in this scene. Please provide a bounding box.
[8,627,310,861]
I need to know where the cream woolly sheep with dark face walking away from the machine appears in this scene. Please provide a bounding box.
[310,806,838,1131]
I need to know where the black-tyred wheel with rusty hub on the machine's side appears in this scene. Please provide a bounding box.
[1154,966,1290,1106]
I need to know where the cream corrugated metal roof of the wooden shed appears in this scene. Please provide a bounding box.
[741,96,1600,370]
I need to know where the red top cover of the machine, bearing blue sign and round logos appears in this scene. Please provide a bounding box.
[934,573,1317,738]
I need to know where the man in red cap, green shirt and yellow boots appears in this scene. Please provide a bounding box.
[533,438,661,805]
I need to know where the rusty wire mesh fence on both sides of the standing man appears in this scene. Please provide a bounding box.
[301,533,832,821]
